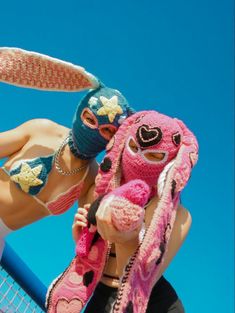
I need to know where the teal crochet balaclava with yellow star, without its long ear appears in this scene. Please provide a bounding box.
[69,86,132,159]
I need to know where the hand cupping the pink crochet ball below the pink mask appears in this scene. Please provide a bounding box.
[96,196,141,244]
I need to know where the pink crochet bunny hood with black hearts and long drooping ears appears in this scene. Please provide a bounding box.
[93,111,198,313]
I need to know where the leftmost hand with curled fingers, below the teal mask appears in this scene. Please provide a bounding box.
[72,204,90,242]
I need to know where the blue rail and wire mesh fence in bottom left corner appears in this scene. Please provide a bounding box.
[0,244,46,313]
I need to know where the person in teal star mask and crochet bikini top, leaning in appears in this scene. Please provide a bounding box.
[0,48,132,258]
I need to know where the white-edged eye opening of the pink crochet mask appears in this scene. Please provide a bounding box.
[128,138,167,163]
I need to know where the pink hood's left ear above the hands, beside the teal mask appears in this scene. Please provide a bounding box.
[95,111,146,195]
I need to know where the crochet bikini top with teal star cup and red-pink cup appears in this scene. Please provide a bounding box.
[2,152,89,215]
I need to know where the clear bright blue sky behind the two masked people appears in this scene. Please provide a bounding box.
[0,0,234,313]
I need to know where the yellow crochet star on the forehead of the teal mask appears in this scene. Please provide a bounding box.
[97,96,123,123]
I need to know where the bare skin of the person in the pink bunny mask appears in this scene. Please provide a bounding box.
[72,141,192,287]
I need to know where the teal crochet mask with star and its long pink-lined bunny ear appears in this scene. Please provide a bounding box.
[0,48,133,159]
